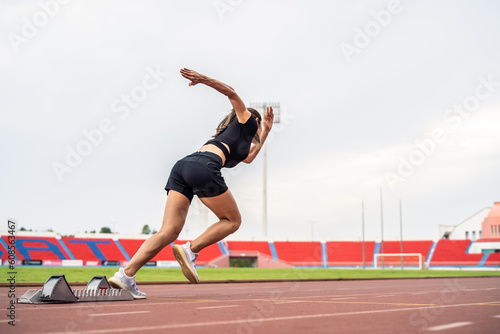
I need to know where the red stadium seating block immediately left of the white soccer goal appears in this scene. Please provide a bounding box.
[326,241,375,266]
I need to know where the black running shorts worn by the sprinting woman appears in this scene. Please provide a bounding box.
[165,152,228,201]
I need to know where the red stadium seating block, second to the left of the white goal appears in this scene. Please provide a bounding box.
[274,241,323,266]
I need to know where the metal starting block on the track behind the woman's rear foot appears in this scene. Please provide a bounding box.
[17,275,134,304]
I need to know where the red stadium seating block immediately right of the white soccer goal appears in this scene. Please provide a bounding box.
[431,240,483,266]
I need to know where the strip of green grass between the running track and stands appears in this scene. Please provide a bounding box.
[0,266,500,283]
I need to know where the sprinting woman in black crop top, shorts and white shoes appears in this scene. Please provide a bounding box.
[109,68,274,299]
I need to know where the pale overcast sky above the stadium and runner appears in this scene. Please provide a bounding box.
[0,0,500,240]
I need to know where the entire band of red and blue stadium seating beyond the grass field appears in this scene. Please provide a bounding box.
[0,234,500,267]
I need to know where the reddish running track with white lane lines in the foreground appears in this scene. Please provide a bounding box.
[0,277,500,334]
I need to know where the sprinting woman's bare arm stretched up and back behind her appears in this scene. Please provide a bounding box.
[181,68,252,123]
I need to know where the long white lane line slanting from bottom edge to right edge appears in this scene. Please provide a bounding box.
[41,302,499,334]
